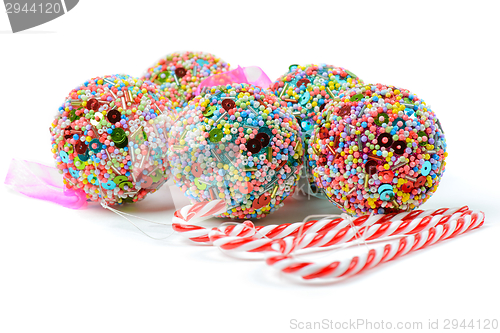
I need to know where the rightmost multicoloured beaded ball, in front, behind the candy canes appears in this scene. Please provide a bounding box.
[309,84,447,215]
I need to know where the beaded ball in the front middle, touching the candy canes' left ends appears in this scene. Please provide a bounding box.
[168,84,303,219]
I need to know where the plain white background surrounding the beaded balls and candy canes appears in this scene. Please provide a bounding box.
[0,0,500,332]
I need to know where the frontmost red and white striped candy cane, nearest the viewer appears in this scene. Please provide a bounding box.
[266,211,484,280]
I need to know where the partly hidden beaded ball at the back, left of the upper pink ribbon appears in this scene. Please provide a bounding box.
[142,51,229,111]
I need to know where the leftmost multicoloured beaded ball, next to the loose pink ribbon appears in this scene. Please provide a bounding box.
[50,75,171,205]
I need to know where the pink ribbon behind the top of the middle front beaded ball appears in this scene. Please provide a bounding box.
[196,66,271,95]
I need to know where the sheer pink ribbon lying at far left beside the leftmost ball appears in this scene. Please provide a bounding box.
[5,159,87,209]
